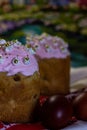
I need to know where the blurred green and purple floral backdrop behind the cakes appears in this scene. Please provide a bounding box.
[0,0,87,68]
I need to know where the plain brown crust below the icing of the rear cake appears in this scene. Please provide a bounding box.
[39,56,70,95]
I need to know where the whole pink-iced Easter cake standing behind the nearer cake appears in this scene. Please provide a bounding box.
[26,34,70,95]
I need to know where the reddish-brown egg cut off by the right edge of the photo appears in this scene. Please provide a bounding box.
[73,92,87,121]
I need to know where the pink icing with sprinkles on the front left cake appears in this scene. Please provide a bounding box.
[0,39,38,76]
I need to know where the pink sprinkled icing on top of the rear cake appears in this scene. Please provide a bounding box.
[26,33,70,59]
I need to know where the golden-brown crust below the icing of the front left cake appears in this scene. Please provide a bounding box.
[0,73,40,122]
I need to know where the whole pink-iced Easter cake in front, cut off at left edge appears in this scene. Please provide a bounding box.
[0,39,40,122]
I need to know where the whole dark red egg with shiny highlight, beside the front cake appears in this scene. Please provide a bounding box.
[40,95,73,130]
